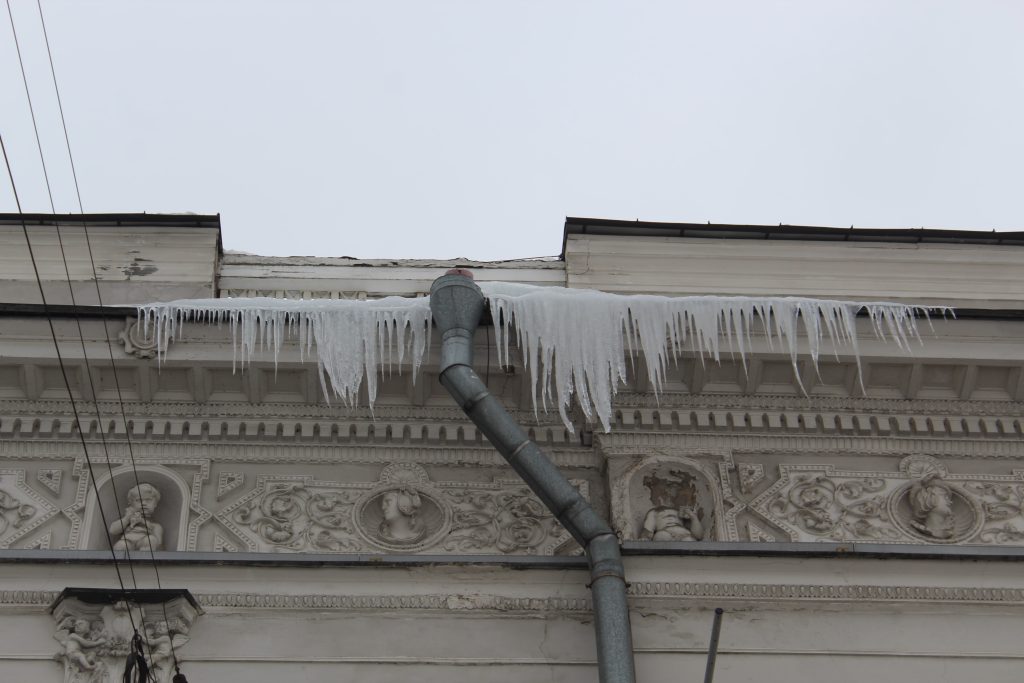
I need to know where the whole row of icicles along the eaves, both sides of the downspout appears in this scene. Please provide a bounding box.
[139,283,951,431]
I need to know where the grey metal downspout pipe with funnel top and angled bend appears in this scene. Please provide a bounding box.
[430,271,636,683]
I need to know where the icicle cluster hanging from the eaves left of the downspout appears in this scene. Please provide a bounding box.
[138,297,430,408]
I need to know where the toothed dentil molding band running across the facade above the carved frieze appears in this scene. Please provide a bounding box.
[0,401,1024,447]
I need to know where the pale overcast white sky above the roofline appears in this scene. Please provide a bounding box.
[0,0,1024,259]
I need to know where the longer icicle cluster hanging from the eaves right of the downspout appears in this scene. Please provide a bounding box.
[480,283,951,431]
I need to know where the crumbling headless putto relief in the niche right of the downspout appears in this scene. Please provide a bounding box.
[640,470,705,541]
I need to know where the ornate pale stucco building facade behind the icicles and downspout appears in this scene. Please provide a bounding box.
[0,215,1024,683]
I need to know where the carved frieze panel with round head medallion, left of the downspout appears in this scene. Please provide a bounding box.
[216,463,587,555]
